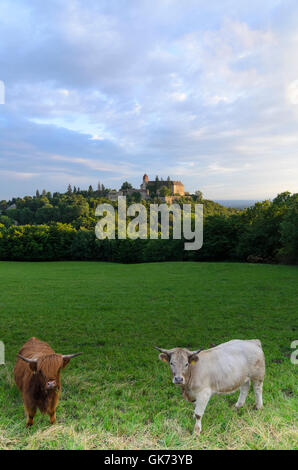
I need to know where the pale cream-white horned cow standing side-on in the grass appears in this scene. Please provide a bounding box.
[156,339,265,435]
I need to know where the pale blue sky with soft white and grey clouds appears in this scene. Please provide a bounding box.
[0,0,298,200]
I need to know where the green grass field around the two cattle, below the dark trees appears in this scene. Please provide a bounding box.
[0,262,298,449]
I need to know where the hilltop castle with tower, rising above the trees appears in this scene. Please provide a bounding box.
[108,173,185,202]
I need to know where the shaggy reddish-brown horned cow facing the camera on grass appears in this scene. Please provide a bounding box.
[14,338,82,427]
